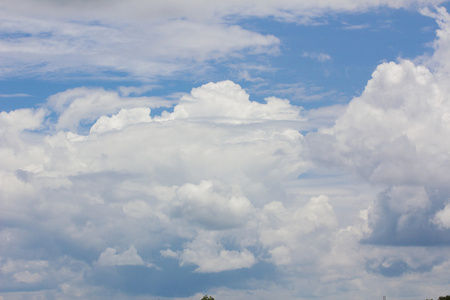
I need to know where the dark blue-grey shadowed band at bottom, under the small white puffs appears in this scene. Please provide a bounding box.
[85,259,278,297]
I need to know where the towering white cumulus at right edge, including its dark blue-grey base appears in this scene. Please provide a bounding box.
[306,10,450,250]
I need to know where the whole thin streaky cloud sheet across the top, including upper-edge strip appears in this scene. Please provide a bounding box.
[0,0,442,82]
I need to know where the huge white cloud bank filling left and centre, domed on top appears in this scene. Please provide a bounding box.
[1,81,312,295]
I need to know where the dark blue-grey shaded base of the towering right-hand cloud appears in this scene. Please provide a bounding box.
[363,186,450,246]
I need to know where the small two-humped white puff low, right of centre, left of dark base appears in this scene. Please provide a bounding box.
[258,195,338,265]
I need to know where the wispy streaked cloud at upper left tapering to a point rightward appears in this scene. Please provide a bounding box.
[0,11,279,82]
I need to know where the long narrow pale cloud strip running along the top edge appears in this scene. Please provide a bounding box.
[2,0,443,21]
